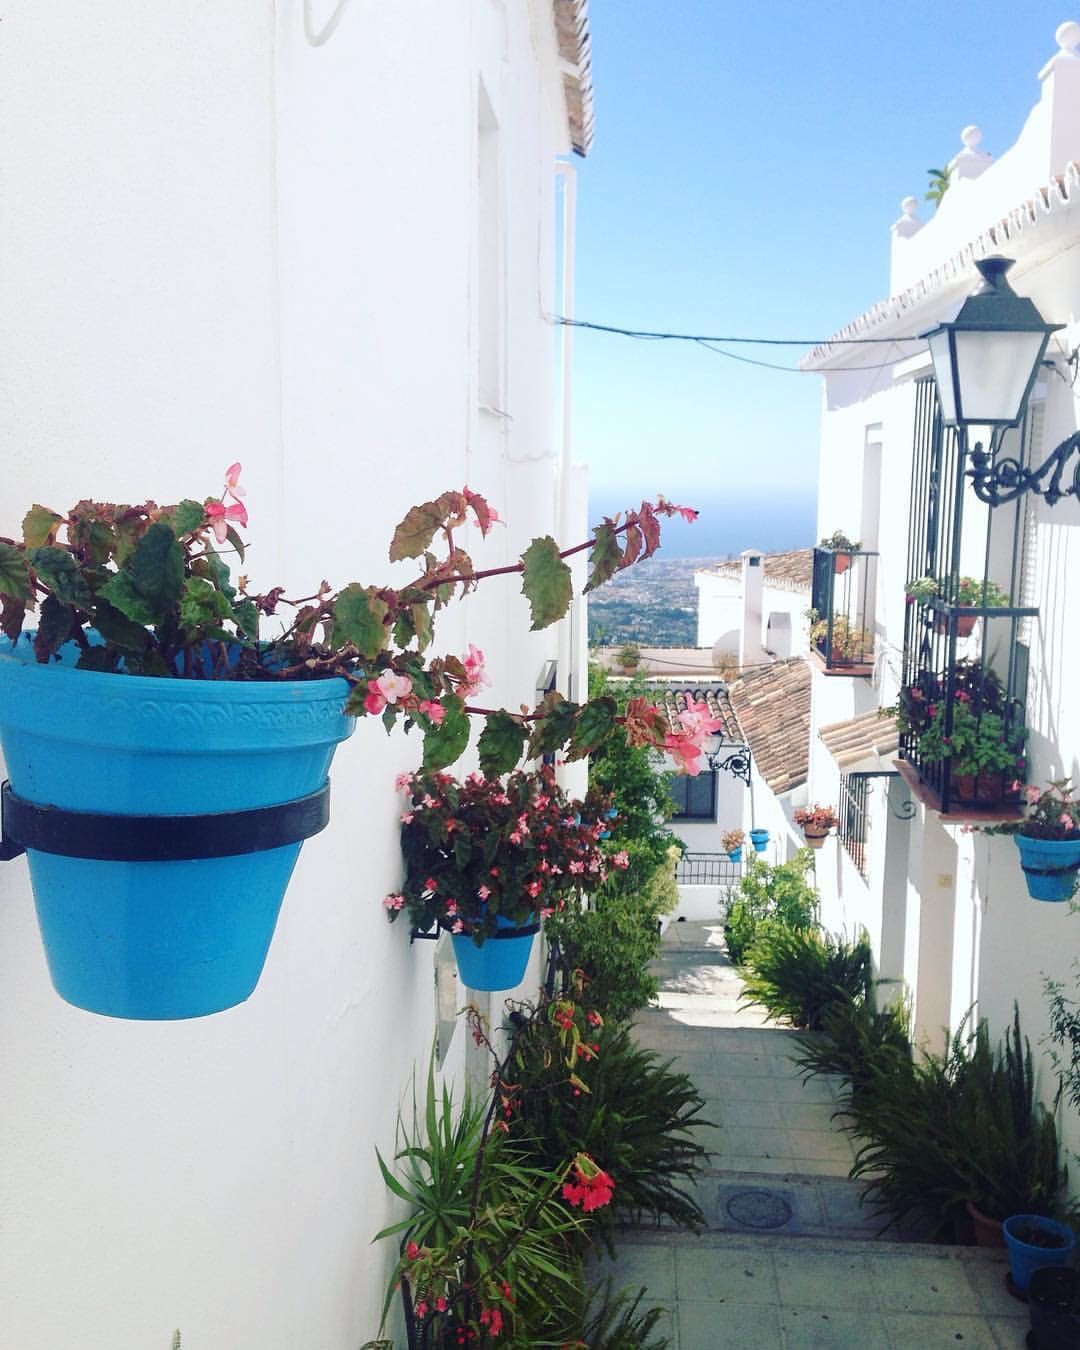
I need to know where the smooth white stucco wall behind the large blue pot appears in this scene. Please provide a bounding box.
[0,0,581,1350]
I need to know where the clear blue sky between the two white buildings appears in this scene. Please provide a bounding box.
[574,0,1080,510]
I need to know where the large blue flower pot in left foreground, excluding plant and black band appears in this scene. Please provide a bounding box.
[0,640,354,1021]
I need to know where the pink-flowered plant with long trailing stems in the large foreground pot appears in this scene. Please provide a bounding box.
[0,464,703,775]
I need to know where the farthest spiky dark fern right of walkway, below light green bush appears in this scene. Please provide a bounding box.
[744,922,873,1031]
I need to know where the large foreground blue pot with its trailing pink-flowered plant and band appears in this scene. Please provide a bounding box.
[0,464,699,1019]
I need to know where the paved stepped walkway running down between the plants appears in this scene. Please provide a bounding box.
[599,923,1027,1350]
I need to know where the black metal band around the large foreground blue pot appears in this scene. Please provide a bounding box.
[0,783,329,863]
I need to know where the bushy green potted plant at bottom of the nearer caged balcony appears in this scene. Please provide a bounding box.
[918,690,1023,803]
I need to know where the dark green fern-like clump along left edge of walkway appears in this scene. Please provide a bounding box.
[510,1022,709,1233]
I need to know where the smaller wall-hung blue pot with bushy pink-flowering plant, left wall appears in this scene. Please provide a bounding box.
[382,765,629,990]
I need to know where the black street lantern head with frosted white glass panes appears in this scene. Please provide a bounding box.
[922,255,1065,428]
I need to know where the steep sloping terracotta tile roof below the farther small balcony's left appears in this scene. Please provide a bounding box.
[728,656,810,792]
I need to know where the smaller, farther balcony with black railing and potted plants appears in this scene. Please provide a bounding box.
[810,548,878,675]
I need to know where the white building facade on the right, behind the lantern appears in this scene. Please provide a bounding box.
[805,24,1080,1145]
